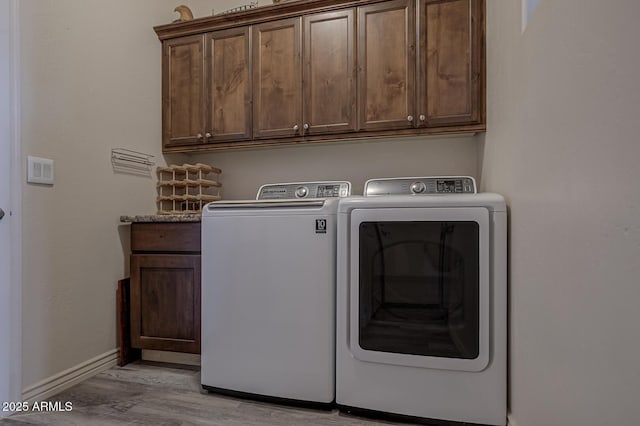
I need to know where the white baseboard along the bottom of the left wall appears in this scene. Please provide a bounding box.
[22,349,118,402]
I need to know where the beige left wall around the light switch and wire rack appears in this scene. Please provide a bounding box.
[20,0,181,388]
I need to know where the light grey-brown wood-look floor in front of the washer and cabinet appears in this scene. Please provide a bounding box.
[0,362,410,426]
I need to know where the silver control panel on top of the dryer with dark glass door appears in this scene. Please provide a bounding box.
[364,176,477,197]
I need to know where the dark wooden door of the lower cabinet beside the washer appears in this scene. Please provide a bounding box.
[131,254,200,353]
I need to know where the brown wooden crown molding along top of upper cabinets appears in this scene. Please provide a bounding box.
[153,0,392,40]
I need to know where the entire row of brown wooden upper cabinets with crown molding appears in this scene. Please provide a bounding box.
[155,0,485,152]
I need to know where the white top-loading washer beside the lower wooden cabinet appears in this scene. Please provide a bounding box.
[201,182,351,408]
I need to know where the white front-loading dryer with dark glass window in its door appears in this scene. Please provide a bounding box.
[336,177,507,425]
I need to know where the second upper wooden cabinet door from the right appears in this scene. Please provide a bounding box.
[358,0,416,130]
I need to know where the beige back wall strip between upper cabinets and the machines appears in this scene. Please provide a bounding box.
[190,136,478,199]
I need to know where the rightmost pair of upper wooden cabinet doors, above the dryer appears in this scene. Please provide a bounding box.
[358,0,484,129]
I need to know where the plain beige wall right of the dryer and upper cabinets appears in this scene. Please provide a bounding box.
[479,0,640,426]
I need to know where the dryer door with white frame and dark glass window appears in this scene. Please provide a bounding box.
[349,207,490,371]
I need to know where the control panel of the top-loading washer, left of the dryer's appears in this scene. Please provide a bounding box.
[256,181,351,200]
